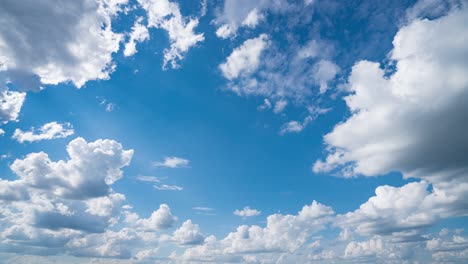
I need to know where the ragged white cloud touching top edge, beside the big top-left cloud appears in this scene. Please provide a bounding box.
[138,0,205,68]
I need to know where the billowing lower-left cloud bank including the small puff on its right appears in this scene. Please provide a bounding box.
[0,138,181,258]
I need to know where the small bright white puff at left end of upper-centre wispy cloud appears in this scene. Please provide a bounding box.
[219,34,268,80]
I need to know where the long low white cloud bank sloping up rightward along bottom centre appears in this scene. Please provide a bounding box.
[178,201,334,262]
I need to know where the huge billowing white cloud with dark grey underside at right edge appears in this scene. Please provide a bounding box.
[314,9,468,188]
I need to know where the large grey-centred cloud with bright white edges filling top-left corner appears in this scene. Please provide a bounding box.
[0,0,126,89]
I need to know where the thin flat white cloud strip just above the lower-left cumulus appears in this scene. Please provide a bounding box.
[12,122,75,143]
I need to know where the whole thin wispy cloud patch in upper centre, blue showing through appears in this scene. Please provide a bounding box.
[220,34,339,106]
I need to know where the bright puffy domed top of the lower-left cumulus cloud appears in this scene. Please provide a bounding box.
[11,138,133,199]
